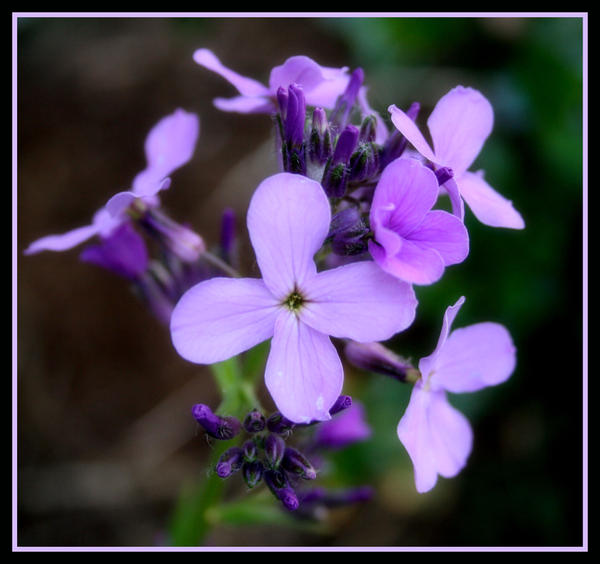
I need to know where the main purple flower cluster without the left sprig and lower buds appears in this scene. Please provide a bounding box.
[180,53,525,492]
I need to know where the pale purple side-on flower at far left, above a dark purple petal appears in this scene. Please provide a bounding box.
[25,109,198,255]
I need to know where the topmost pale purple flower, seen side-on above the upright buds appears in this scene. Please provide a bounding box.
[194,49,349,114]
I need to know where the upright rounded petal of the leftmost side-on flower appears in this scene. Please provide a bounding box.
[133,109,199,196]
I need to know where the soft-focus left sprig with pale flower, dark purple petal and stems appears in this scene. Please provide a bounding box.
[25,109,217,325]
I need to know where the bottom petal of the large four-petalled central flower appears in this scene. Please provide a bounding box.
[265,310,344,423]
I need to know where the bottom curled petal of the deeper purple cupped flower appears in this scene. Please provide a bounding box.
[369,240,445,285]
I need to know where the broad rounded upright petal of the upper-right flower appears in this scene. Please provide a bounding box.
[425,86,494,177]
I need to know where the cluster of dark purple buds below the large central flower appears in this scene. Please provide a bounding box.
[192,396,370,511]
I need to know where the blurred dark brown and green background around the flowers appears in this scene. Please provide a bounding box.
[16,17,584,547]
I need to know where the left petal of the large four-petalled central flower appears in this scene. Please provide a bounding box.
[171,278,279,364]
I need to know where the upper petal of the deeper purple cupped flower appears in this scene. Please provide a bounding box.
[371,158,439,239]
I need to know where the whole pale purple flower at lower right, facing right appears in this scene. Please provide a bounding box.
[397,297,516,493]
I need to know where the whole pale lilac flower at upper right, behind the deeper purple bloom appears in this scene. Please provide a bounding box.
[389,86,525,229]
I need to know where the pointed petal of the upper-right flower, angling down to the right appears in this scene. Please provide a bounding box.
[458,171,525,229]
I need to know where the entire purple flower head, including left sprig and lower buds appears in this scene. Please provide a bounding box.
[26,49,525,496]
